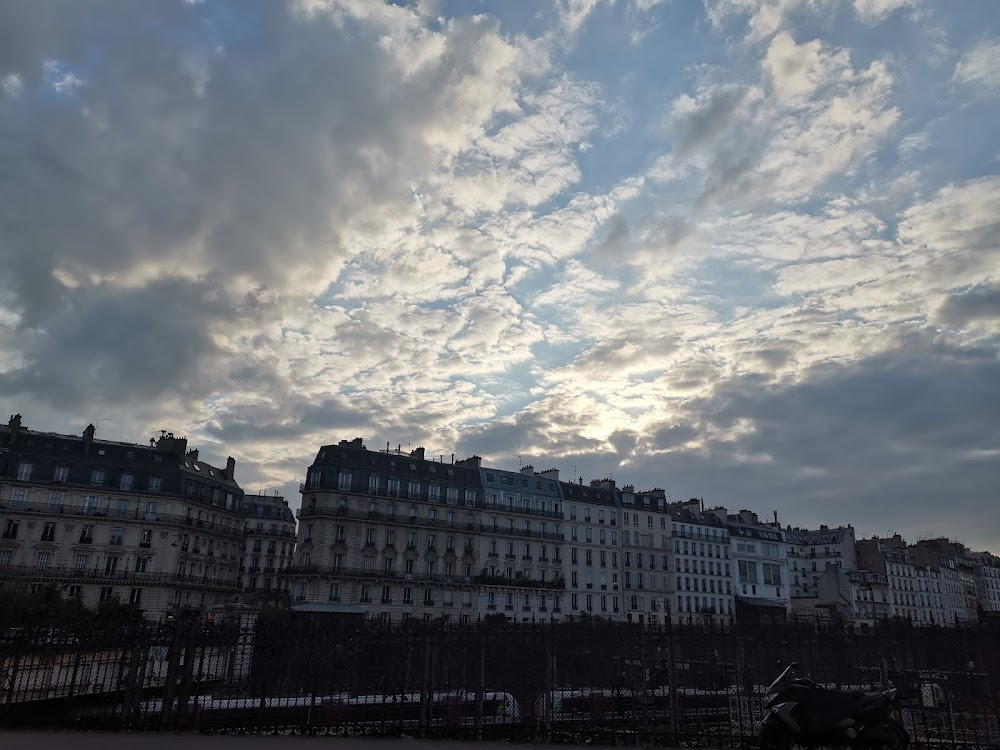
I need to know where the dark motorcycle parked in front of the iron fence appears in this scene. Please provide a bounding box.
[760,662,910,750]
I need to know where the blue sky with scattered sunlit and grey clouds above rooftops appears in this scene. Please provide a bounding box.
[0,0,1000,552]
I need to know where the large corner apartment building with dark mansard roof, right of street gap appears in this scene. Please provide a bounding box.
[286,438,490,622]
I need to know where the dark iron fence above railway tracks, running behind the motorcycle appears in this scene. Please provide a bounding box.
[0,616,1000,748]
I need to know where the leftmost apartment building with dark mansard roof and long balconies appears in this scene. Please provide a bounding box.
[0,414,243,619]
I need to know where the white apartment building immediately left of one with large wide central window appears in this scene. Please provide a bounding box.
[670,499,735,622]
